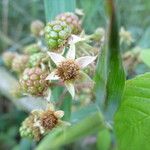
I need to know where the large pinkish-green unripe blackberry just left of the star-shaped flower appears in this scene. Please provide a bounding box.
[20,67,49,96]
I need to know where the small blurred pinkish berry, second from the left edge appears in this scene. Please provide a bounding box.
[12,55,29,73]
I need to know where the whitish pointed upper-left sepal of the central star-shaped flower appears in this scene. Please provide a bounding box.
[47,52,65,66]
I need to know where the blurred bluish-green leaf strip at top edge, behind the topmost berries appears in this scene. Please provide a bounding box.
[44,0,76,22]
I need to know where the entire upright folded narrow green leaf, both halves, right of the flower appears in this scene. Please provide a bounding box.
[95,0,125,114]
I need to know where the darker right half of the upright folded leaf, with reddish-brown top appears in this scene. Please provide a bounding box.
[106,0,125,102]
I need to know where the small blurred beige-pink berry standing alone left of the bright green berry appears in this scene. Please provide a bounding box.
[30,20,44,37]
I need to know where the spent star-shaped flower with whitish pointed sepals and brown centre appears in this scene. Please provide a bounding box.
[46,38,96,98]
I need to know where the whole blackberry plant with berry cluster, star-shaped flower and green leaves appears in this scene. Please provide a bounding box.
[3,0,150,150]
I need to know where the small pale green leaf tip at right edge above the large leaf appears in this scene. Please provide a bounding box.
[139,49,150,67]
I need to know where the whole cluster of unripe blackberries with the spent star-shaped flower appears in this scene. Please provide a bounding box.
[3,12,102,141]
